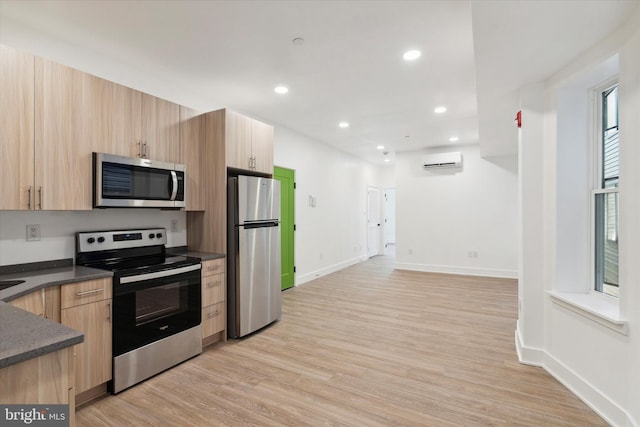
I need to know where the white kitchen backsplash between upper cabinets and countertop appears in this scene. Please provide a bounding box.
[0,209,187,265]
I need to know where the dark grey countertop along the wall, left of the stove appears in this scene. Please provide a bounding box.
[0,265,113,302]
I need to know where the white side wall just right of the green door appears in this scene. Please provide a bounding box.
[274,125,393,284]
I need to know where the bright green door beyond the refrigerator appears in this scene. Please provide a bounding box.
[273,166,296,290]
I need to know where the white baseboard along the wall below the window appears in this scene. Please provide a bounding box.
[515,329,640,427]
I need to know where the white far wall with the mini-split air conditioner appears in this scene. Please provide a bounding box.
[396,145,518,278]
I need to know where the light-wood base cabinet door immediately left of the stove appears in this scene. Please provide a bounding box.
[60,299,111,394]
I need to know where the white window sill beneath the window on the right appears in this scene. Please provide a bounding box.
[547,291,629,335]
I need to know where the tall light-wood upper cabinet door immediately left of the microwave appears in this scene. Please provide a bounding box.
[35,58,94,210]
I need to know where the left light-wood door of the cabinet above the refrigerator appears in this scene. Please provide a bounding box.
[225,110,253,169]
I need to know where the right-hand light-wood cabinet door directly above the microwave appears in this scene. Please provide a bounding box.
[142,93,182,163]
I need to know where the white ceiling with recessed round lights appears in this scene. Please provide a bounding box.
[0,0,640,164]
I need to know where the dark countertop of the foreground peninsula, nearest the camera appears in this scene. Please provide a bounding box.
[0,302,84,368]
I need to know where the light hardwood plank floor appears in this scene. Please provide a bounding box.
[77,257,607,427]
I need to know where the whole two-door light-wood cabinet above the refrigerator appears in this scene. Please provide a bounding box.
[224,110,273,175]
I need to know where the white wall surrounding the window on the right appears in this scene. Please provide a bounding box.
[516,8,640,426]
